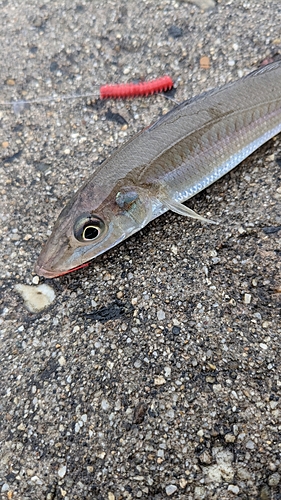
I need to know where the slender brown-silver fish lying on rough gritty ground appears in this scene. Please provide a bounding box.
[35,61,281,278]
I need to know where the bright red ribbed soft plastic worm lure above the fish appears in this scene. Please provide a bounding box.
[100,76,174,99]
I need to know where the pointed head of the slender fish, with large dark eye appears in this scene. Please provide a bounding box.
[35,181,152,278]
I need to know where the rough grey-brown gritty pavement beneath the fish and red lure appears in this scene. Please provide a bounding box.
[0,0,281,500]
